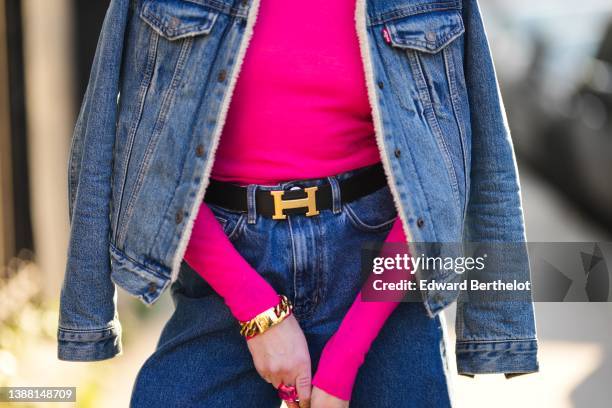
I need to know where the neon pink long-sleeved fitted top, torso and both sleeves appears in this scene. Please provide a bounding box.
[185,0,406,400]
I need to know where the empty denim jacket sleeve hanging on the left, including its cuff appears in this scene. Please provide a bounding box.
[57,0,129,361]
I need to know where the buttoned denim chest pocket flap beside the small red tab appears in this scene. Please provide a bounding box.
[386,10,465,54]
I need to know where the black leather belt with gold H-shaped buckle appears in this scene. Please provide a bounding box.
[204,163,387,220]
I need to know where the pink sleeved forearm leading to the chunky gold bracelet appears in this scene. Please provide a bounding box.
[184,203,278,321]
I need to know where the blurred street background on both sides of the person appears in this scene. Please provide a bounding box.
[0,0,612,408]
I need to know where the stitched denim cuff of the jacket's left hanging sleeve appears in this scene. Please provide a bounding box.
[57,324,122,361]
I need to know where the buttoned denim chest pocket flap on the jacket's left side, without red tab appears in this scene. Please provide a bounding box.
[140,0,219,40]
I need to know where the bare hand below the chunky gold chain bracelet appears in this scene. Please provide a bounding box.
[247,314,311,408]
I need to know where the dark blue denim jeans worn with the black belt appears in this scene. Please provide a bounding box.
[130,164,450,408]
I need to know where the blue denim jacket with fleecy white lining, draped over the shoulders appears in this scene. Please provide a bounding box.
[58,0,538,375]
